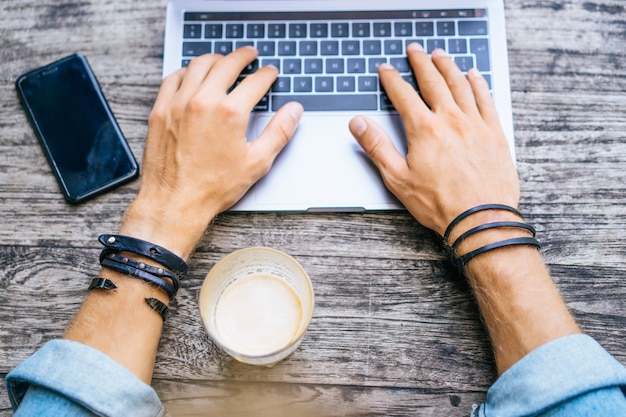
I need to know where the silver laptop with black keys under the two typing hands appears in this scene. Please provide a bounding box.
[163,0,515,211]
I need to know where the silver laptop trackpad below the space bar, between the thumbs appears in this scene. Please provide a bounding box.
[253,114,406,210]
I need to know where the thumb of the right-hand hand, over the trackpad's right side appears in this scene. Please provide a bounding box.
[349,116,408,184]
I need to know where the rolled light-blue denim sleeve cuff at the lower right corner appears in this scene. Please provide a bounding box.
[472,335,626,417]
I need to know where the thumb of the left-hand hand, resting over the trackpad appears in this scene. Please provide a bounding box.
[248,102,304,179]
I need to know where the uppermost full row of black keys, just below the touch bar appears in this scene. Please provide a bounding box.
[183,20,487,39]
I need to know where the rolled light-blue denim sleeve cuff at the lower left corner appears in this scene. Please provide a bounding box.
[6,340,165,417]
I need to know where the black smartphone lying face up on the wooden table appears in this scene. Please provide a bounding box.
[15,54,139,204]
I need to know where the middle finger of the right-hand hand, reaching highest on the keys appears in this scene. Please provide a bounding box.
[406,42,454,111]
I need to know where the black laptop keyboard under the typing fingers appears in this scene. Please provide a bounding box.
[181,9,491,112]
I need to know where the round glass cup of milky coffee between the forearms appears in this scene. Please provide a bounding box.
[199,248,315,366]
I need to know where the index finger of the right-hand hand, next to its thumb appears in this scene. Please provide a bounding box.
[378,64,430,127]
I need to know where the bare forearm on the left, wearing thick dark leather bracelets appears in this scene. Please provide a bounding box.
[64,198,212,383]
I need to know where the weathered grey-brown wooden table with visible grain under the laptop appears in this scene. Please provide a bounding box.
[0,0,626,416]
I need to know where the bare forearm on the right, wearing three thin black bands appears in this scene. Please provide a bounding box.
[448,211,580,374]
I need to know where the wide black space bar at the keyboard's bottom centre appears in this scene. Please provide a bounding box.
[272,94,378,111]
